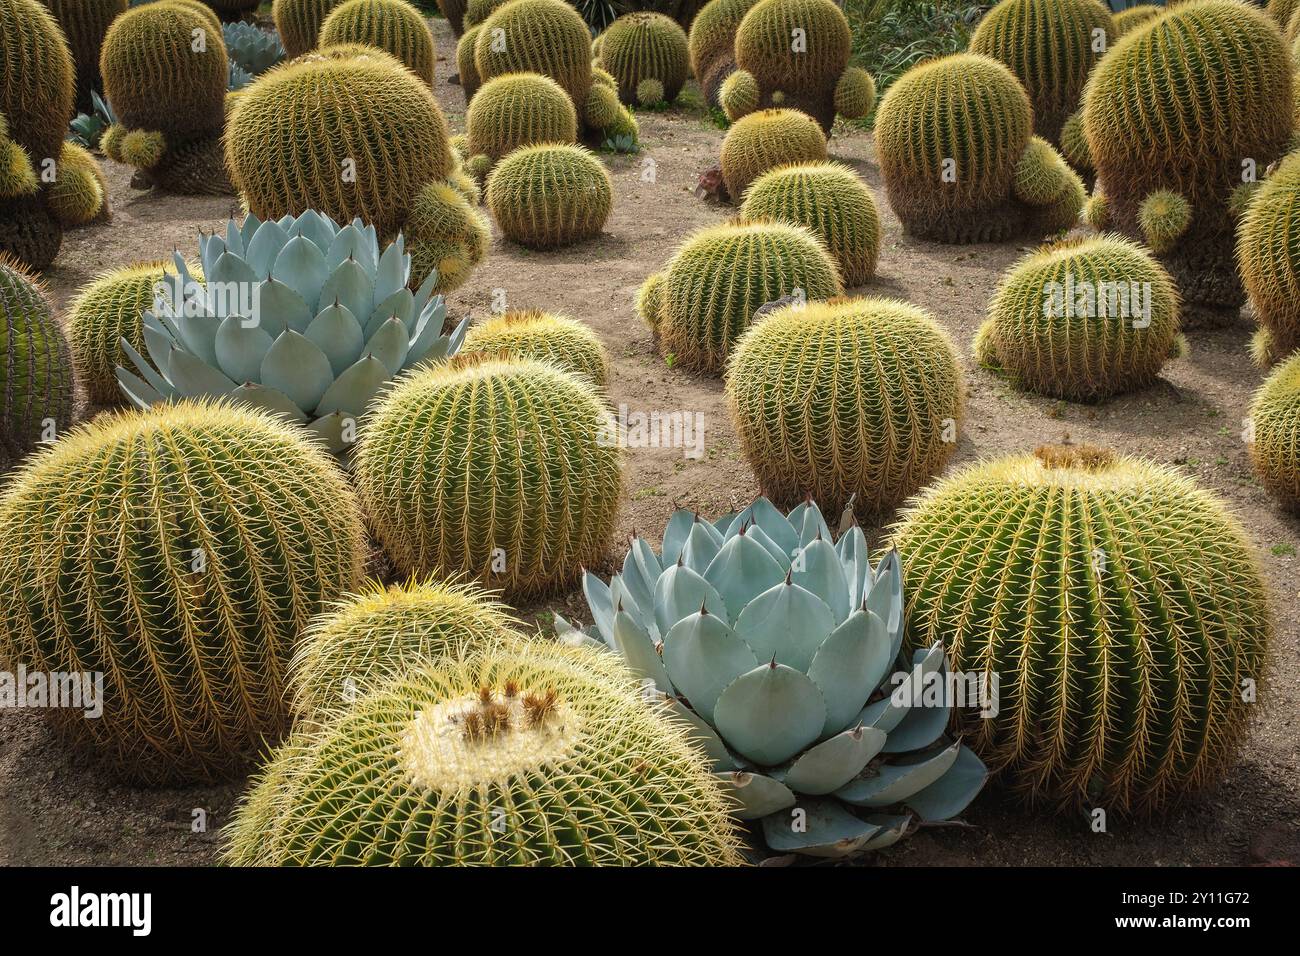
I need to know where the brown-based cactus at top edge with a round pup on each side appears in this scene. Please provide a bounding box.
[719,0,876,135]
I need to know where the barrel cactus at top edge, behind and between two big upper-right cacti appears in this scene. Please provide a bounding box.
[970,0,1118,143]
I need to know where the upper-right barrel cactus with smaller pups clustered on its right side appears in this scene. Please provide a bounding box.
[876,53,1086,243]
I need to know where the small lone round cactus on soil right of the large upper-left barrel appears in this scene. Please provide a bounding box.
[486,144,614,248]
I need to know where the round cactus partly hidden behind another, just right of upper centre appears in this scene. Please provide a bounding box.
[740,163,880,287]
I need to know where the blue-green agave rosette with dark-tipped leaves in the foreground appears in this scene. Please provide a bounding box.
[556,498,988,857]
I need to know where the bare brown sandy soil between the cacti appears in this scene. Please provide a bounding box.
[0,21,1300,865]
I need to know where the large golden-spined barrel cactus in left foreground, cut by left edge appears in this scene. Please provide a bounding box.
[0,402,364,783]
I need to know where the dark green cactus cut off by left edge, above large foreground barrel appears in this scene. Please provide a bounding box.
[0,256,73,468]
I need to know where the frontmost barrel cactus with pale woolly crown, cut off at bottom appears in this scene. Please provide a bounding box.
[226,648,744,866]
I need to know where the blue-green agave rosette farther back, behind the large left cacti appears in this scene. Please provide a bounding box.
[117,211,468,453]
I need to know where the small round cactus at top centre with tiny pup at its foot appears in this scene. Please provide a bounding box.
[599,12,689,107]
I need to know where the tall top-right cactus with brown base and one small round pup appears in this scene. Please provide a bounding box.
[1083,0,1294,310]
